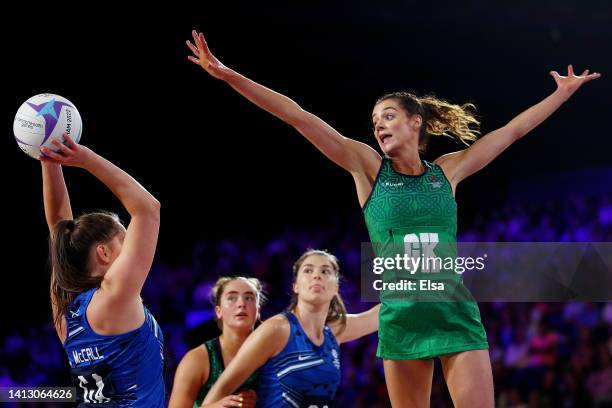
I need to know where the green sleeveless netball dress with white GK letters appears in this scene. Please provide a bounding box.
[363,157,488,360]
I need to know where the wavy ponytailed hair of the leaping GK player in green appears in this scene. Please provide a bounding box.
[376,92,480,153]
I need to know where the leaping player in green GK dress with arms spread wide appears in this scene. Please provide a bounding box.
[187,31,600,407]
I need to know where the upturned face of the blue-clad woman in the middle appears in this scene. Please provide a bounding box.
[293,255,338,303]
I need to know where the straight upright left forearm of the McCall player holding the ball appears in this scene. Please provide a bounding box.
[41,161,72,230]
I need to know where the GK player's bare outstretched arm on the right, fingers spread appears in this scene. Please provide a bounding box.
[436,65,601,191]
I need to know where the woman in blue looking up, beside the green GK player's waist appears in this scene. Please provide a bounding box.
[202,250,379,408]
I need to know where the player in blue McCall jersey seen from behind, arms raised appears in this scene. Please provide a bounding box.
[41,135,165,408]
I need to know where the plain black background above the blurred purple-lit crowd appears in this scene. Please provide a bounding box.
[0,1,612,334]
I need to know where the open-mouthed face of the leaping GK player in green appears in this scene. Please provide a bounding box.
[372,99,422,156]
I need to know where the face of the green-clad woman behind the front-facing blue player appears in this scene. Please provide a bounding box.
[215,279,259,331]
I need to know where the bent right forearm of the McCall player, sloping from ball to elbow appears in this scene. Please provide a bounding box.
[83,151,159,217]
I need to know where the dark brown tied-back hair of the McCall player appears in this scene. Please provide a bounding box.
[49,211,122,326]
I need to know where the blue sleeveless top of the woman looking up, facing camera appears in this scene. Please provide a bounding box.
[257,312,340,408]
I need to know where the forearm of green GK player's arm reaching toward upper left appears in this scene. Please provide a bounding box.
[223,69,306,126]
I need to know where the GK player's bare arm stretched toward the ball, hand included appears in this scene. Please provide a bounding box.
[187,30,381,177]
